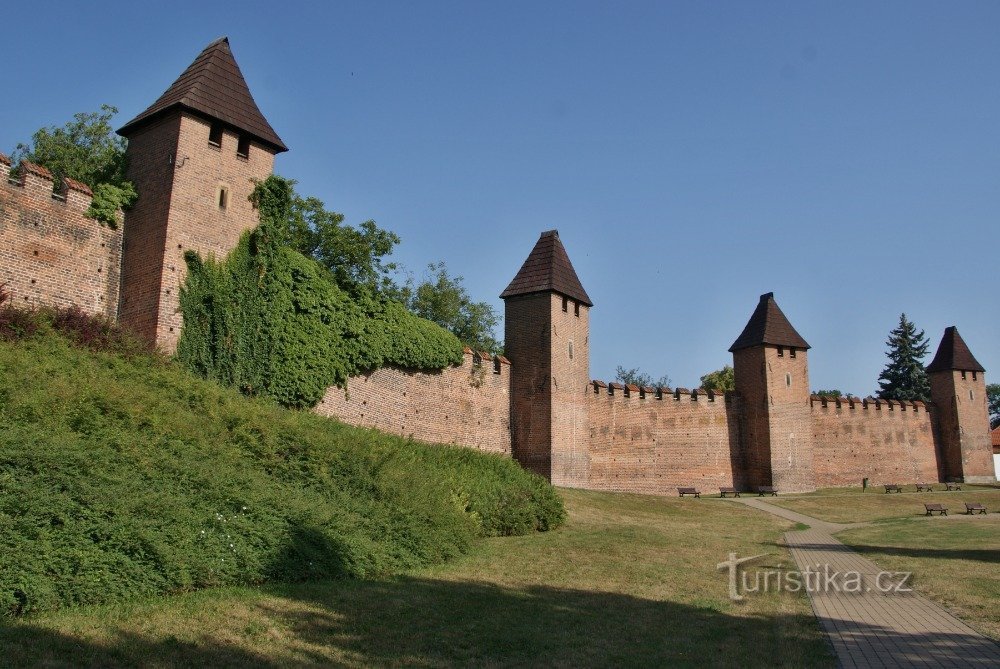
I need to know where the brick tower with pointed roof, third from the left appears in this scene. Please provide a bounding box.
[729,293,816,492]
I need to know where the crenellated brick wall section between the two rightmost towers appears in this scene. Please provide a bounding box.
[811,398,943,487]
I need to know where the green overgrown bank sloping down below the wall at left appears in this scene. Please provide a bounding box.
[0,334,562,616]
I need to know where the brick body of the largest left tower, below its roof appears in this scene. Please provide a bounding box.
[121,113,274,352]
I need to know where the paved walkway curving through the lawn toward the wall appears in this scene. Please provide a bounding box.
[737,498,1000,668]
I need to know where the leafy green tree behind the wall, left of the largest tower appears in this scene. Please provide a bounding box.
[13,105,138,227]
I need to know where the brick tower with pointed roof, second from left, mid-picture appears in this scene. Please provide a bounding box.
[500,230,593,487]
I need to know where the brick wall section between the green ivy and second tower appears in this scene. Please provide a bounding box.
[315,352,511,455]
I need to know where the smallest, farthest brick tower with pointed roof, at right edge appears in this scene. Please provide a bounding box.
[927,325,996,483]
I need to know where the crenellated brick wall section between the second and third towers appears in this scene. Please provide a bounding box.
[587,382,745,495]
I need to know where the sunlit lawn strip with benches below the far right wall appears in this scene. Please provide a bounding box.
[767,484,1000,523]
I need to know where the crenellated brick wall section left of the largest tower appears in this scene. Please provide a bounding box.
[0,159,122,318]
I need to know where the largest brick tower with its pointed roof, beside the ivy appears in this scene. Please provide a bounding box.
[118,37,288,352]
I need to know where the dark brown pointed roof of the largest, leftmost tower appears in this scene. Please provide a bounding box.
[118,37,288,153]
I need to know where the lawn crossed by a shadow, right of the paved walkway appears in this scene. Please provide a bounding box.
[837,516,1000,641]
